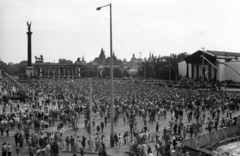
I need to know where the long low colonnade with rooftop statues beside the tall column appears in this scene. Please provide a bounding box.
[34,56,82,79]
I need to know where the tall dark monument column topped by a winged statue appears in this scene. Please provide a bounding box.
[26,22,33,76]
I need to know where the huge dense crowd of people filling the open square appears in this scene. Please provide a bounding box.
[0,79,240,156]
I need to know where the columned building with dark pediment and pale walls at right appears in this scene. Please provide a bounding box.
[178,50,240,82]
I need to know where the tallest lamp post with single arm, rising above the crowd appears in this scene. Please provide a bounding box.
[96,3,114,140]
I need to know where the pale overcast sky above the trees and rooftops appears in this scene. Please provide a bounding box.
[0,0,240,63]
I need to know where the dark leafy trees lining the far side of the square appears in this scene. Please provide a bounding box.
[0,52,189,80]
